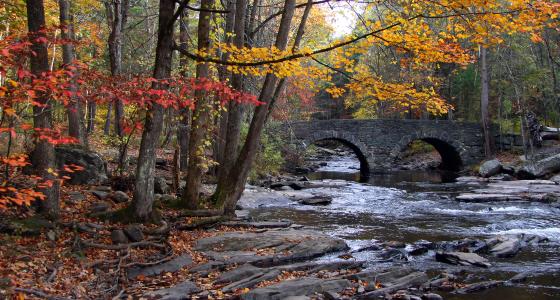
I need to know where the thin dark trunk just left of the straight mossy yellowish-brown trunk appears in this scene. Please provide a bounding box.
[177,10,191,172]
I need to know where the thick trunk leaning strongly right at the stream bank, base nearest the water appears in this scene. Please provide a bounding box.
[214,0,295,215]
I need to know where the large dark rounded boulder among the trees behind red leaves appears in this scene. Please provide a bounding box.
[55,146,108,184]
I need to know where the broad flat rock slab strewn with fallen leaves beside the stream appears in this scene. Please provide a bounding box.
[195,229,348,267]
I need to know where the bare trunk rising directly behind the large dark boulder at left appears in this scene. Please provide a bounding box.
[58,0,87,145]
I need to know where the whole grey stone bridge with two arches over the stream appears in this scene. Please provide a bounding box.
[283,119,484,175]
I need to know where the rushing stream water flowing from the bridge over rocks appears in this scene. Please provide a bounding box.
[244,157,560,300]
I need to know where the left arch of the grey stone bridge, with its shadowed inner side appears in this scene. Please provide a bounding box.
[304,130,370,176]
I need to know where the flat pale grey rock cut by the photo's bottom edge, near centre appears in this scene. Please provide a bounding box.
[241,277,351,300]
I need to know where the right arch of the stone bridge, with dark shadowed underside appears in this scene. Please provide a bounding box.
[390,131,468,171]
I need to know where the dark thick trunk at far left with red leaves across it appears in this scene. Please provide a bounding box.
[26,0,60,219]
